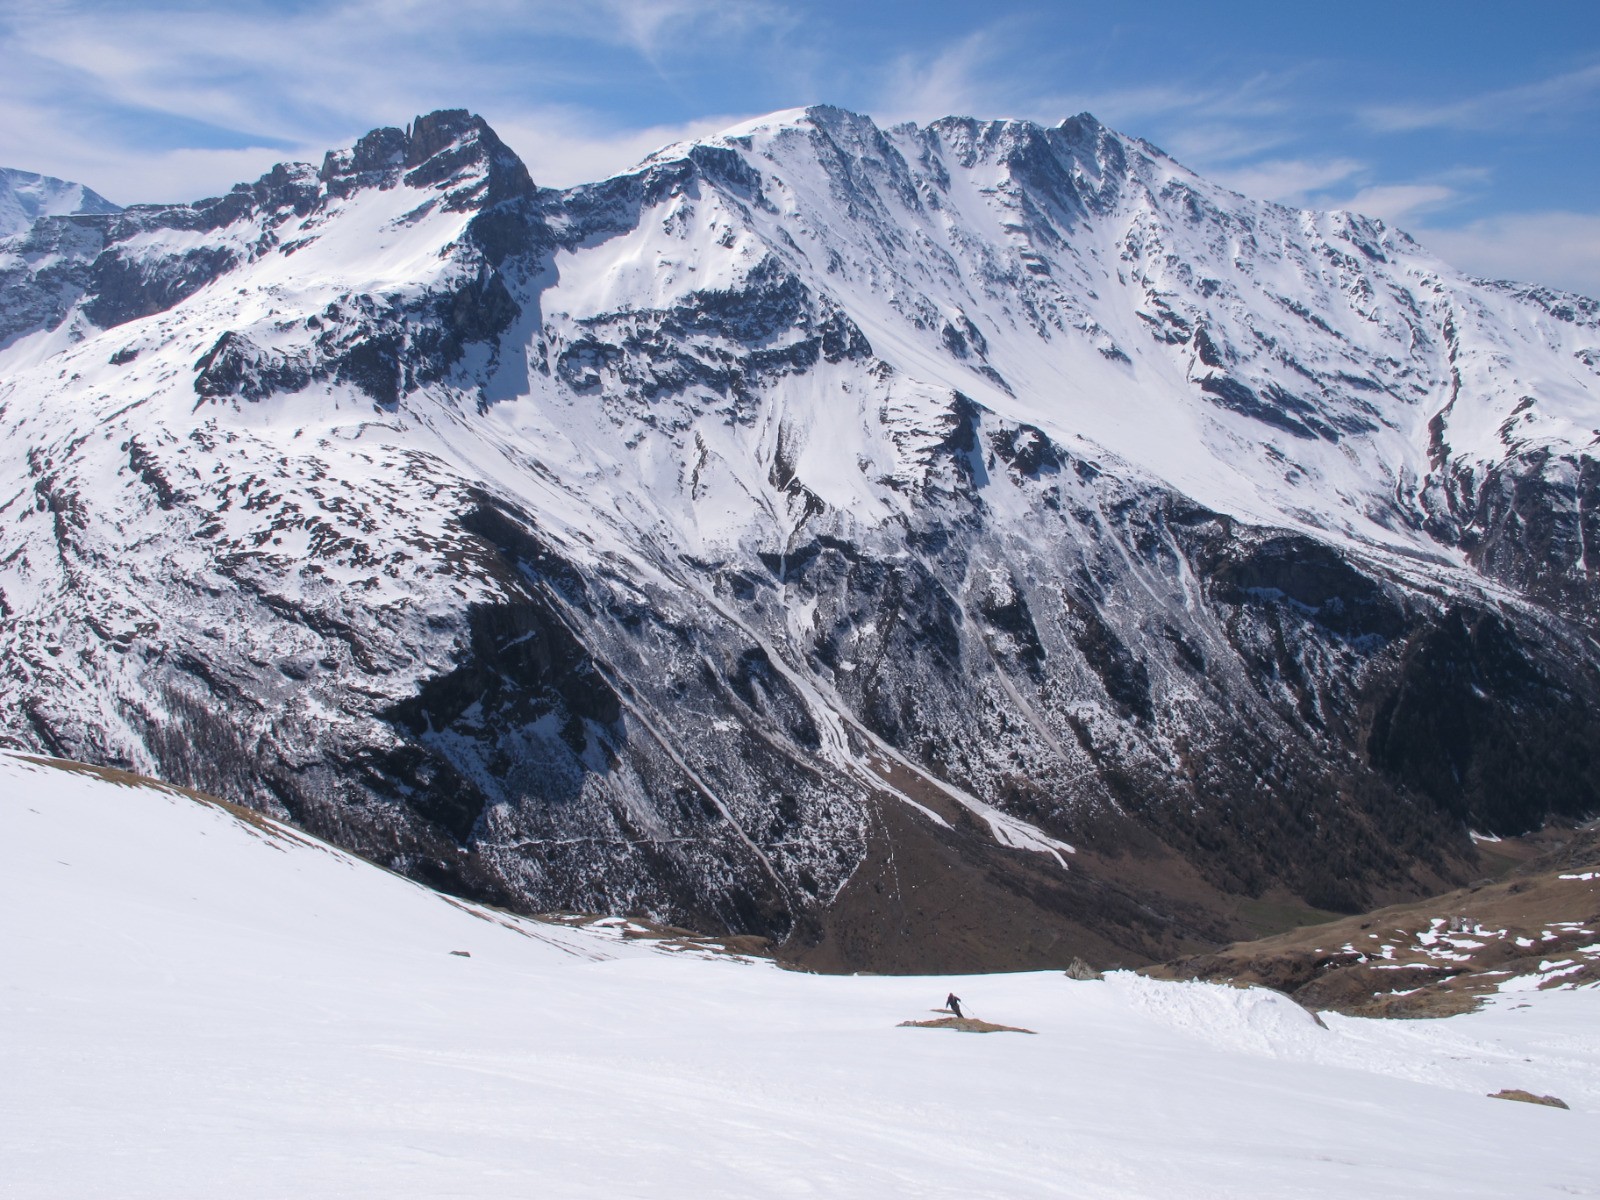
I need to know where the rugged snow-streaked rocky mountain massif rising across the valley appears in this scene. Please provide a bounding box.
[0,107,1600,970]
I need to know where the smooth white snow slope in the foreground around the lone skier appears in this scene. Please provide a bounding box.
[0,755,1600,1200]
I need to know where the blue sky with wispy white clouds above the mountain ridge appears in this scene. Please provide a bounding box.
[9,0,1600,294]
